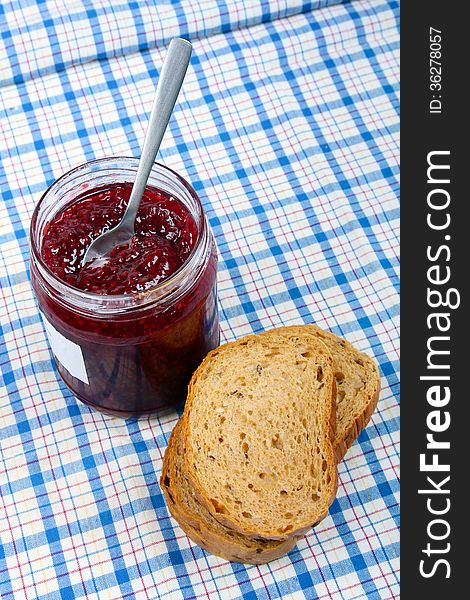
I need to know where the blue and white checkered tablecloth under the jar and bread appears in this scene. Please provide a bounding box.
[0,0,399,600]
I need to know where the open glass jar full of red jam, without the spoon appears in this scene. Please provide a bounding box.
[30,158,219,417]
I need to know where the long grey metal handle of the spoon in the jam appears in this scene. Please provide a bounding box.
[123,38,192,230]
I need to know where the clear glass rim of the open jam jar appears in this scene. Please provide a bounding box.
[29,156,209,313]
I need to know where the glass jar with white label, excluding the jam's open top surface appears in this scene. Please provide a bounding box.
[30,158,219,417]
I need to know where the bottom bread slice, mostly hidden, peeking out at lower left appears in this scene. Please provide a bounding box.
[160,419,297,565]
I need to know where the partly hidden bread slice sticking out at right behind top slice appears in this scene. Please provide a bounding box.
[261,325,380,462]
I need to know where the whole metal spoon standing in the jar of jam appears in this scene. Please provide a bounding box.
[82,38,192,267]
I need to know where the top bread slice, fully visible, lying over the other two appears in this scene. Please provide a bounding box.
[183,331,337,540]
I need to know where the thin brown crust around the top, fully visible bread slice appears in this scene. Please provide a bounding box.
[183,330,338,540]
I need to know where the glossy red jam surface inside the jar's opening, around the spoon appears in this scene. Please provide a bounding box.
[42,183,197,294]
